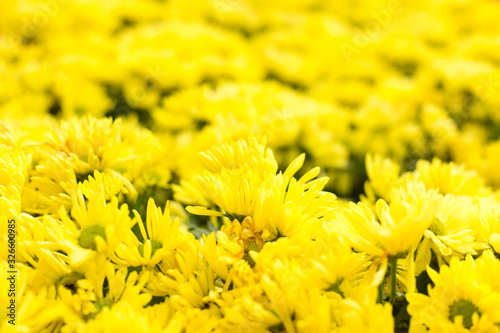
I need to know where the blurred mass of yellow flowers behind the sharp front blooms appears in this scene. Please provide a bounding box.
[0,0,500,199]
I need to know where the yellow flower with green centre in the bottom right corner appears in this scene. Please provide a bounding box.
[406,255,500,332]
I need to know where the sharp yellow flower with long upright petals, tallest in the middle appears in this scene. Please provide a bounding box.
[187,139,337,240]
